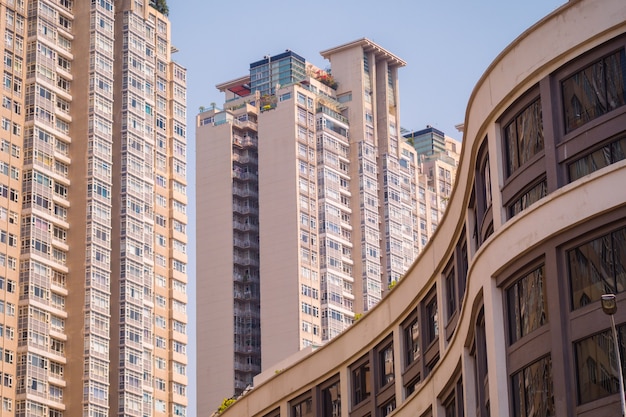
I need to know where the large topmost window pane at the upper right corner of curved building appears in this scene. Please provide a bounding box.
[561,49,626,133]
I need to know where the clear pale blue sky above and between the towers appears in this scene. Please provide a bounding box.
[168,0,566,417]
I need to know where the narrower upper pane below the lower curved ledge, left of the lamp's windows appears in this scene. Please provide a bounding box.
[507,265,548,343]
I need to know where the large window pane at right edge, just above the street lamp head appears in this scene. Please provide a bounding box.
[567,227,626,309]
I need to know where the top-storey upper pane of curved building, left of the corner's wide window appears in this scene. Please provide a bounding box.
[504,99,544,175]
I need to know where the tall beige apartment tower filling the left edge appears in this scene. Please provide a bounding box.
[0,0,187,417]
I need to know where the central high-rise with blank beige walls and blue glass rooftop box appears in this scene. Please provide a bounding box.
[196,39,419,412]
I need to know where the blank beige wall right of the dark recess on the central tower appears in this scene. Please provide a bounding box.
[259,94,301,371]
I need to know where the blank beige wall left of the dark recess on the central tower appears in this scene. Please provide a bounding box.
[195,118,234,410]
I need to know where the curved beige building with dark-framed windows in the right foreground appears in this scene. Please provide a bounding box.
[218,0,626,417]
